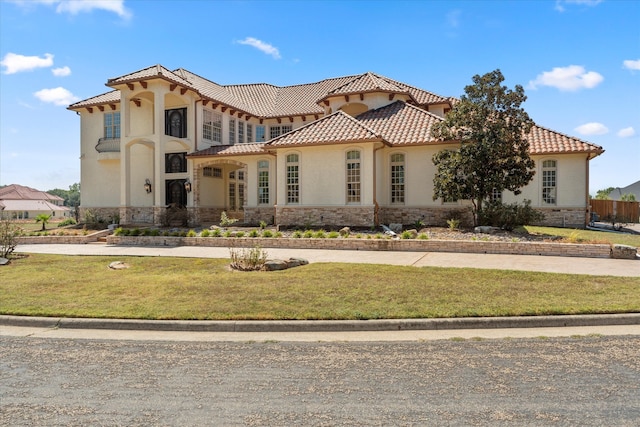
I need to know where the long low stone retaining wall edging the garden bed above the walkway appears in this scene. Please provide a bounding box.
[107,236,611,258]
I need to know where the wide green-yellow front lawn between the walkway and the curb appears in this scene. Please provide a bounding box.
[0,254,640,319]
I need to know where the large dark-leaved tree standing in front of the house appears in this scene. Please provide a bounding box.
[431,70,535,224]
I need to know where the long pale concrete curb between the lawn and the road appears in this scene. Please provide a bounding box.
[0,313,640,332]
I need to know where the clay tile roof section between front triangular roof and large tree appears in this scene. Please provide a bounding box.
[356,101,443,145]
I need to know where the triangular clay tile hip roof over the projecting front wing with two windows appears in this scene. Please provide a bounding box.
[267,111,383,148]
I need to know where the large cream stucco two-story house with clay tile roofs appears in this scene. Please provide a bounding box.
[68,65,604,227]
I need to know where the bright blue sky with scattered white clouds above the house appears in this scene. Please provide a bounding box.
[0,0,640,194]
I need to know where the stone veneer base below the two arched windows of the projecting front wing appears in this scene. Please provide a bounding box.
[276,206,374,227]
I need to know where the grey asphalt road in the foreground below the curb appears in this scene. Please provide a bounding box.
[0,336,640,426]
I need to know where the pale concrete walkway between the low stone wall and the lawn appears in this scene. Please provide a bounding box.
[16,243,640,277]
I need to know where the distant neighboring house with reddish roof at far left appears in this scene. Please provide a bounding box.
[0,184,70,219]
